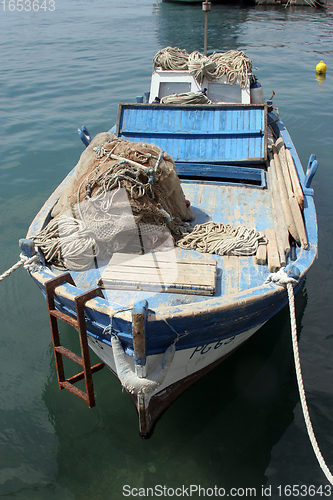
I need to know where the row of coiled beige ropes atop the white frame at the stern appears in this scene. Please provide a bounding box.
[153,47,252,88]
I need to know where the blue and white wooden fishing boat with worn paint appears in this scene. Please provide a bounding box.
[21,47,317,436]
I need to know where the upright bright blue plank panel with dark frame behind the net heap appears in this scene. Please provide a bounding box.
[117,104,267,163]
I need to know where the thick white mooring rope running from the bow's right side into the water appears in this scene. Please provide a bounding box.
[266,268,333,485]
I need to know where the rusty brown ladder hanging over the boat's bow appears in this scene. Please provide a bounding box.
[45,273,104,408]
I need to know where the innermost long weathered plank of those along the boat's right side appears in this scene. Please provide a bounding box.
[269,156,290,266]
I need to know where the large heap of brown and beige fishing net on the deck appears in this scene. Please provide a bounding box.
[35,133,192,270]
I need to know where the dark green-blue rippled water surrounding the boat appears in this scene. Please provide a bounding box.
[0,0,333,500]
